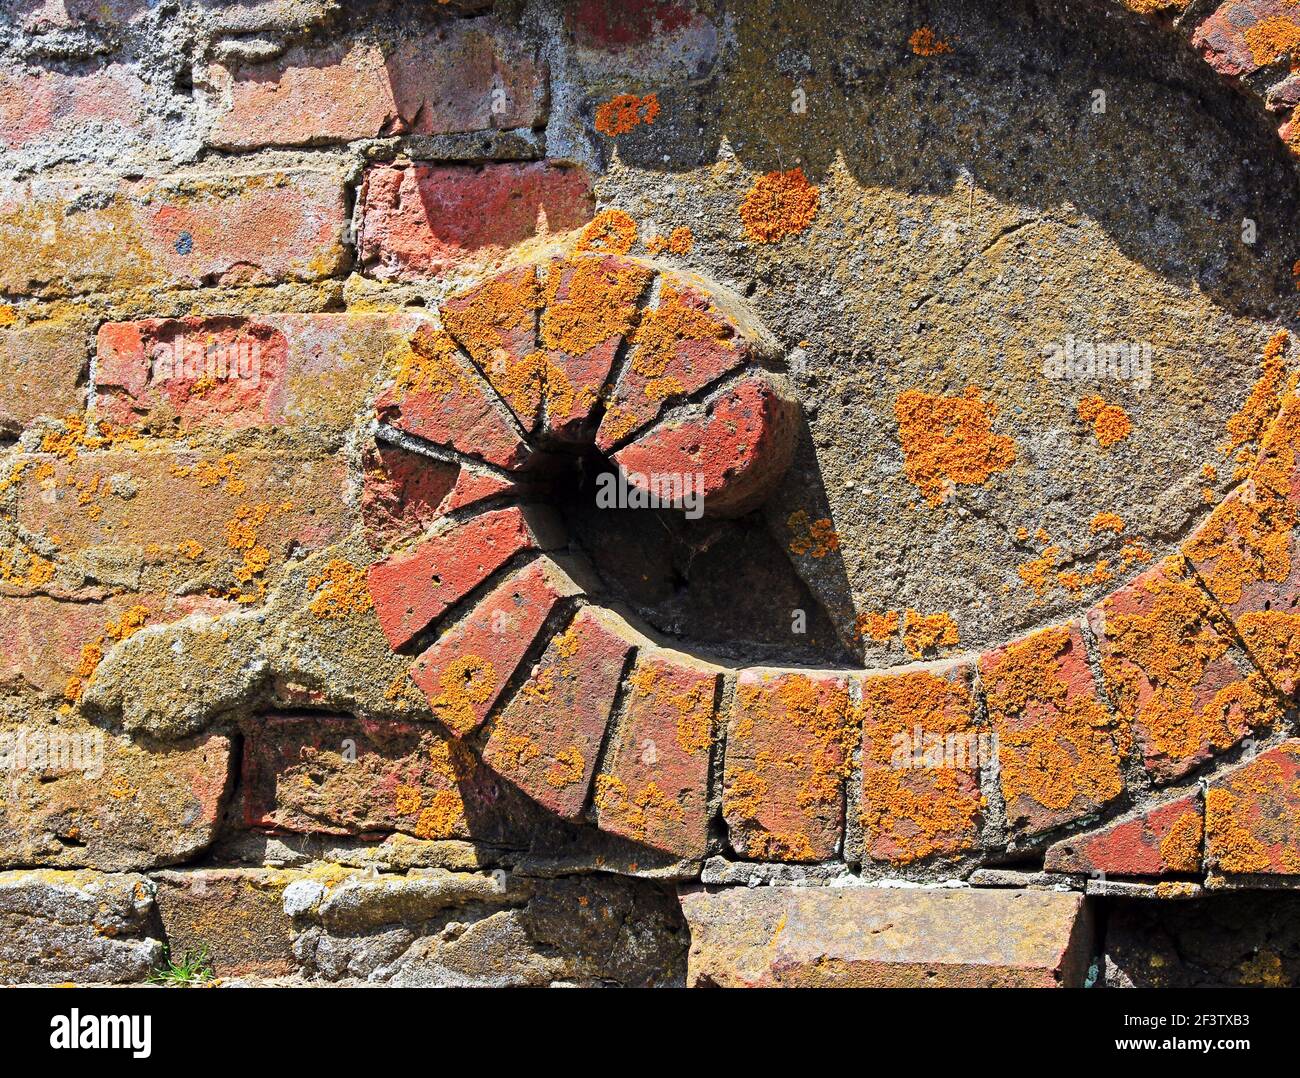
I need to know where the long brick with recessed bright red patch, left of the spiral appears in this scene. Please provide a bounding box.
[95,313,428,433]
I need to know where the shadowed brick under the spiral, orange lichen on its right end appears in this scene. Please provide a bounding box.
[241,715,536,845]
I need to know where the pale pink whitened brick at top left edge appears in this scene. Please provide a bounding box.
[0,64,154,153]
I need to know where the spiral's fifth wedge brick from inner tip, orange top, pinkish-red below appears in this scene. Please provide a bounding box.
[377,326,528,468]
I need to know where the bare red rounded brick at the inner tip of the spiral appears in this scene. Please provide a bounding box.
[614,375,797,516]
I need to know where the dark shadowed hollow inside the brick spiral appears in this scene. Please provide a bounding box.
[550,449,849,664]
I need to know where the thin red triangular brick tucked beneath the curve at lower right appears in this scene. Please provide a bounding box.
[1043,793,1204,876]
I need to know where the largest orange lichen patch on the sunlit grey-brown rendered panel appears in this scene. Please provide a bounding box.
[894,386,1015,506]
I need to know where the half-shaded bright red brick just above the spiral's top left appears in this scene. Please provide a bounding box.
[359,161,595,281]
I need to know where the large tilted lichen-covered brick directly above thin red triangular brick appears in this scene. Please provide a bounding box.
[1088,558,1282,780]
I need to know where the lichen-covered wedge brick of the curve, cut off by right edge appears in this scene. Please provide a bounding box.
[1183,393,1300,696]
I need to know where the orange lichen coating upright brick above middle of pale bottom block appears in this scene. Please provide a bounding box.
[859,671,980,865]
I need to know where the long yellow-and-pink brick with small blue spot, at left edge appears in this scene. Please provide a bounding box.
[0,169,346,296]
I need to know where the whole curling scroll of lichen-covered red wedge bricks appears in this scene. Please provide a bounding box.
[368,239,1300,871]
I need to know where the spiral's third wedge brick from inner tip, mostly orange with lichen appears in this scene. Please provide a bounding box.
[541,255,654,441]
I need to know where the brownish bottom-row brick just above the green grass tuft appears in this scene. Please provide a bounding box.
[153,869,306,978]
